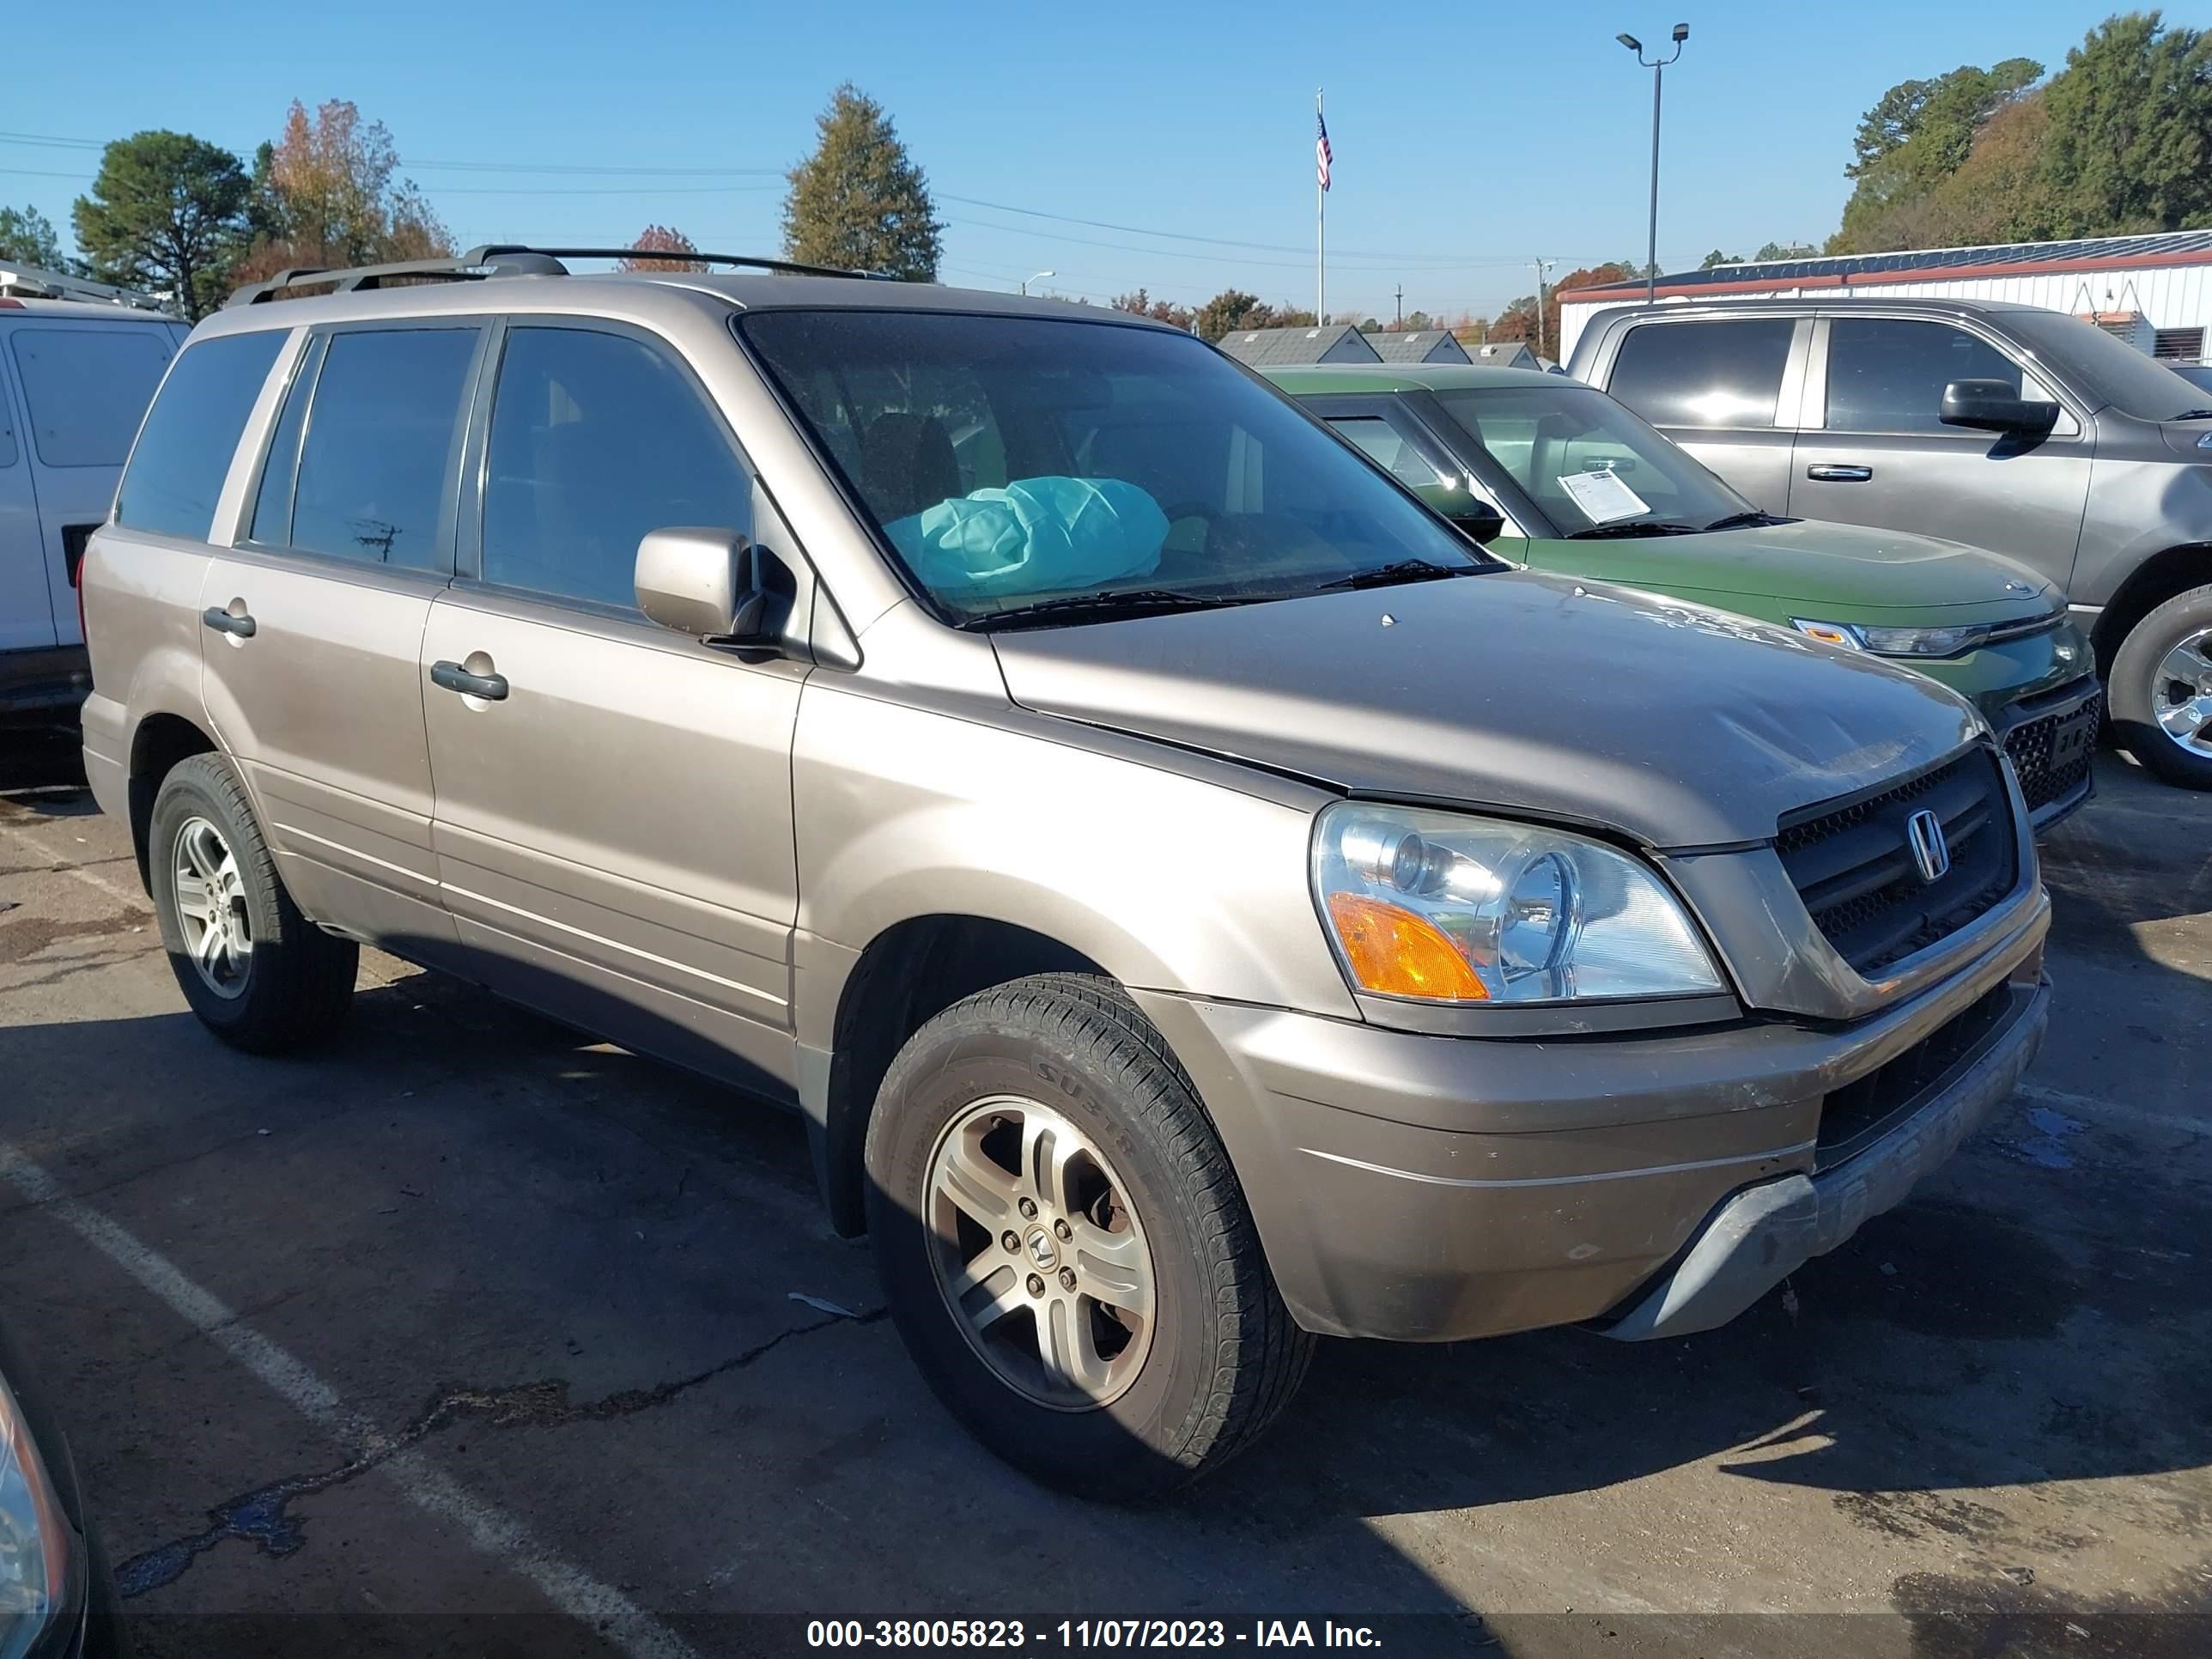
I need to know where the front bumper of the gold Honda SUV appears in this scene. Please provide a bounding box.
[1134,894,2051,1343]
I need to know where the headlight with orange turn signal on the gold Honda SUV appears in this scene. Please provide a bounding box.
[1314,801,1723,1002]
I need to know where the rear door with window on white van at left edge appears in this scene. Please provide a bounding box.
[9,312,177,646]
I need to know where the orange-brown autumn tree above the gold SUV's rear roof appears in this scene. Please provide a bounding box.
[237,97,453,281]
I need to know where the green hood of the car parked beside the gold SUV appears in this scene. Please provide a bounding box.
[1526,517,2061,623]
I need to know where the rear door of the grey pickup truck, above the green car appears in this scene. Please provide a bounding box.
[1597,316,1812,514]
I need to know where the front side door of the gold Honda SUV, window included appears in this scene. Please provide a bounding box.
[420,321,805,1088]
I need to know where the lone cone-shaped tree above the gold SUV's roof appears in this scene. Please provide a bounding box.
[783,82,945,283]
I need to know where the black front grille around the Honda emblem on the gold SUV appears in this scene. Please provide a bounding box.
[1774,748,2020,975]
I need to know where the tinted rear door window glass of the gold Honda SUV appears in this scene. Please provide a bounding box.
[289,327,477,571]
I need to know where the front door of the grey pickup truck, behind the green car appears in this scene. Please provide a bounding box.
[1787,314,2094,586]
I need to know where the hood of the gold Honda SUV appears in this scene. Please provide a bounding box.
[991,571,1980,848]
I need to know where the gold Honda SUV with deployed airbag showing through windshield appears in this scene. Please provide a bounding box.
[84,248,2051,1495]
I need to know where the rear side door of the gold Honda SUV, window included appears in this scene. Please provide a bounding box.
[201,319,484,960]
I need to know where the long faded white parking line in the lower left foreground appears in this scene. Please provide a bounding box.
[0,1141,696,1659]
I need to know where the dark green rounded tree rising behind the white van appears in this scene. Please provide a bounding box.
[70,131,248,321]
